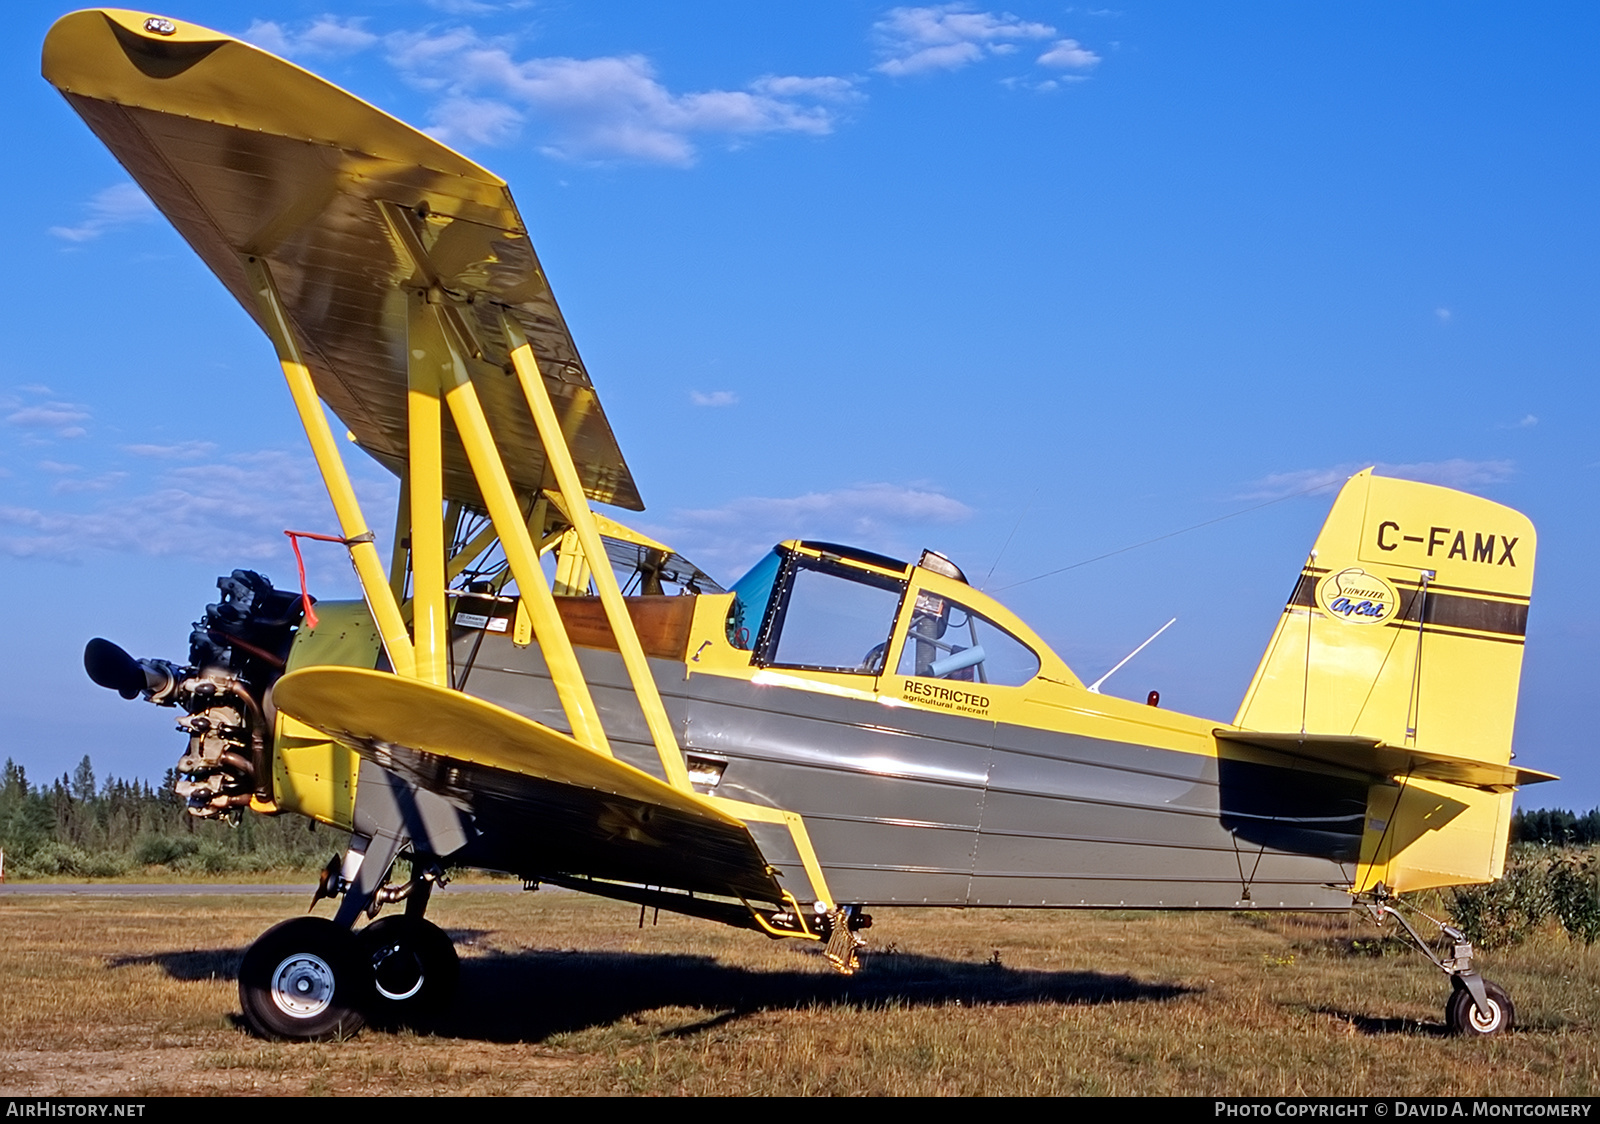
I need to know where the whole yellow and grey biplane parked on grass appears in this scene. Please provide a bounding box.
[53,10,1547,1038]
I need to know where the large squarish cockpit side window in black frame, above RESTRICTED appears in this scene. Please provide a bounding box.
[766,559,904,676]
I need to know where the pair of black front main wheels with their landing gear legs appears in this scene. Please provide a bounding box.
[238,860,461,1041]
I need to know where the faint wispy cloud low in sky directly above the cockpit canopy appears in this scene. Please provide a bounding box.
[640,484,973,581]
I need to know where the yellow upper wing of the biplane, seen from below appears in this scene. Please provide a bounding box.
[43,10,643,511]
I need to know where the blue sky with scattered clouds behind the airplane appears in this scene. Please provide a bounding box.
[0,0,1600,809]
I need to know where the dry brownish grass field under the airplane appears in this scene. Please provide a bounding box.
[0,890,1600,1095]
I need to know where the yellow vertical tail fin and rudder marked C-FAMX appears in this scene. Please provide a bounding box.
[1235,469,1536,890]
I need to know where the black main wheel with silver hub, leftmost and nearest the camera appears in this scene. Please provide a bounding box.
[238,917,371,1041]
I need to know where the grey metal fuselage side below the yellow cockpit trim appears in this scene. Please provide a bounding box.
[454,631,1365,909]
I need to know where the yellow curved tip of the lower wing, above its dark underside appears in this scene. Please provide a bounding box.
[272,668,744,828]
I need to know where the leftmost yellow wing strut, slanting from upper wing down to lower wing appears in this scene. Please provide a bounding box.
[242,255,416,677]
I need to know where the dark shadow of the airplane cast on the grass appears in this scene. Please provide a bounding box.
[106,930,1190,1042]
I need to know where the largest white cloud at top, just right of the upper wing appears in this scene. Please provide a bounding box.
[386,29,859,167]
